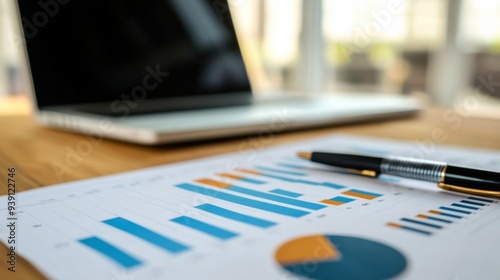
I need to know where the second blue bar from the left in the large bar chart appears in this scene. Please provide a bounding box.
[102,217,189,253]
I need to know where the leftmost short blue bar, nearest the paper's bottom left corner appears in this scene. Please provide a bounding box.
[78,236,142,268]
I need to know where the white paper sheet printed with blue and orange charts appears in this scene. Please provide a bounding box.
[0,135,500,280]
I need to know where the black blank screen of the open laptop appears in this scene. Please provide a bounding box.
[18,0,251,114]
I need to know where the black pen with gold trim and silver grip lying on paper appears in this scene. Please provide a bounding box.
[297,152,500,197]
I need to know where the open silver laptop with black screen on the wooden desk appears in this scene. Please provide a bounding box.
[13,0,419,145]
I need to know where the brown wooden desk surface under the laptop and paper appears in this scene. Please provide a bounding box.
[0,96,500,279]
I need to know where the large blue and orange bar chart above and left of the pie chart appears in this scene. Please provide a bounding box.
[71,163,394,268]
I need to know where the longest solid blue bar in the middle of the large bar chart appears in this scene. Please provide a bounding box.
[175,183,309,218]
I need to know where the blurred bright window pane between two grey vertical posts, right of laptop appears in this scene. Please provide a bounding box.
[323,0,445,92]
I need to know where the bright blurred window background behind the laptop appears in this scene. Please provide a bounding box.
[0,0,500,109]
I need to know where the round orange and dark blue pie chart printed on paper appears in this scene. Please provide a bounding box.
[275,235,407,280]
